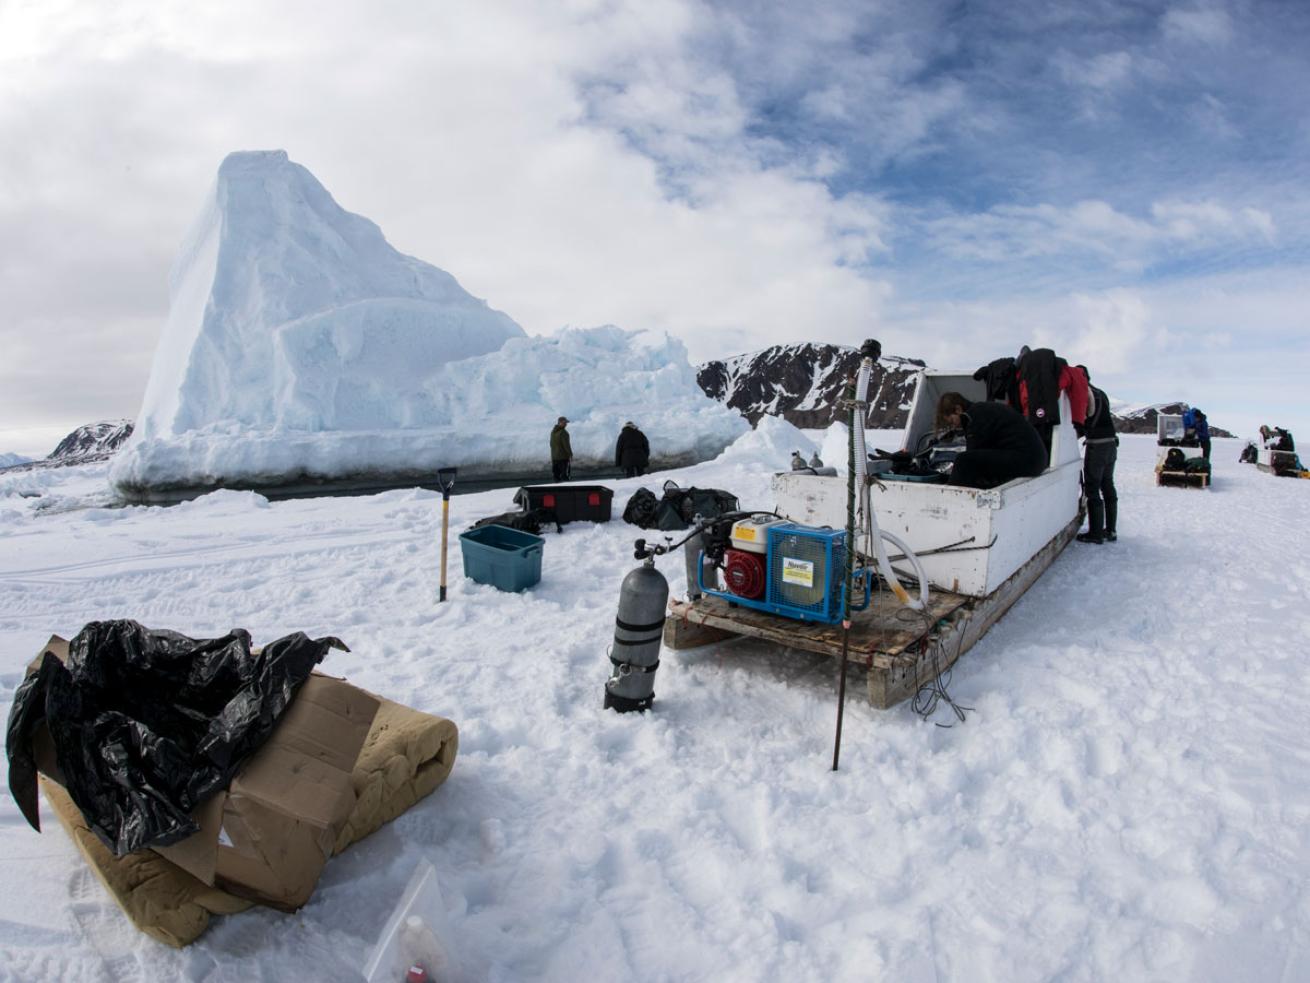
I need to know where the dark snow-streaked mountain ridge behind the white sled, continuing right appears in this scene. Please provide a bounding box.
[696,342,1233,436]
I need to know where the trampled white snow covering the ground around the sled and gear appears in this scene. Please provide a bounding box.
[0,430,1310,983]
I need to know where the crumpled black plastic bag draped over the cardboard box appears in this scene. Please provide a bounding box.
[5,620,346,856]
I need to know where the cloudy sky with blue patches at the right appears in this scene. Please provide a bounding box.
[0,0,1310,456]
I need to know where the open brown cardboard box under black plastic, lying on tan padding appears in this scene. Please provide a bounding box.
[26,636,379,911]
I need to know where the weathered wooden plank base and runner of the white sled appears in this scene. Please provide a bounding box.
[664,514,1082,709]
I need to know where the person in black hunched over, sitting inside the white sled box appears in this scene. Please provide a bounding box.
[937,392,1047,488]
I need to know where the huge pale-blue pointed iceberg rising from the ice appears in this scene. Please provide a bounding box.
[111,151,745,495]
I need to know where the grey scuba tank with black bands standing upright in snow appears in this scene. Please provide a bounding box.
[605,557,668,713]
